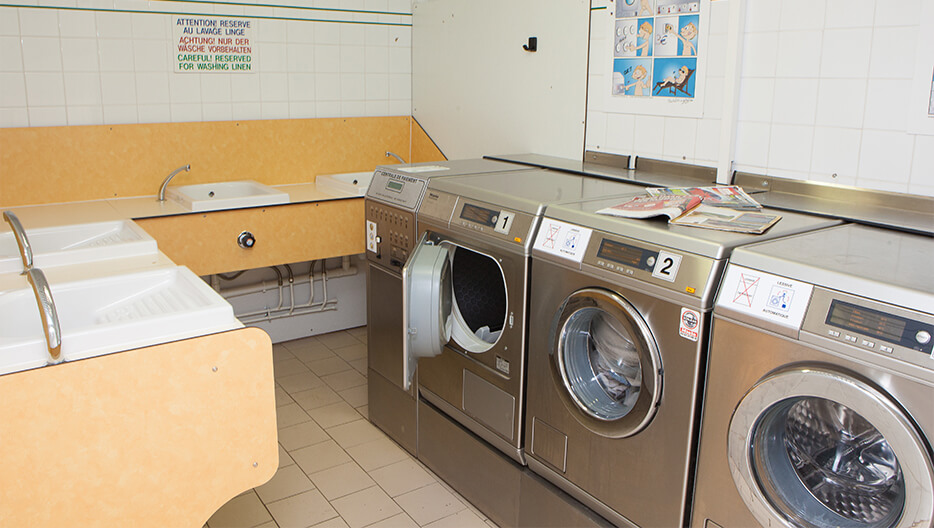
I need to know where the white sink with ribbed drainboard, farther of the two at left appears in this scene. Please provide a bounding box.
[0,220,158,273]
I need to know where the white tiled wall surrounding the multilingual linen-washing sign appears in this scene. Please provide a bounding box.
[0,0,412,127]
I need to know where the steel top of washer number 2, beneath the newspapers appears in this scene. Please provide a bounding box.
[545,197,841,259]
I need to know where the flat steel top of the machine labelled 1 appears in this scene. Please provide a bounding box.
[428,168,645,215]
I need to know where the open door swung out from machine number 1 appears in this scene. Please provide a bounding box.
[402,235,453,390]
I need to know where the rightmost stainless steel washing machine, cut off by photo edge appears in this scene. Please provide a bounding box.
[691,224,934,528]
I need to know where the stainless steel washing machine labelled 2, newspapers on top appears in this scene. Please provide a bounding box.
[526,198,839,527]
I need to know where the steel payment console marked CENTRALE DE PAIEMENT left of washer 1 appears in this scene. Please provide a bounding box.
[365,159,527,454]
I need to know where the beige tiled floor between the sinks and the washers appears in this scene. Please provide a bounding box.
[207,327,496,528]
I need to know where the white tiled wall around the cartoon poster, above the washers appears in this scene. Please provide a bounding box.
[587,0,934,196]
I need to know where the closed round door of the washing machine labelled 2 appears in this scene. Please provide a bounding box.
[551,288,662,438]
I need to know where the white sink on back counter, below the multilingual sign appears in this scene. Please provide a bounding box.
[165,180,289,213]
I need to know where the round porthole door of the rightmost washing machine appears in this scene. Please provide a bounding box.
[732,366,934,528]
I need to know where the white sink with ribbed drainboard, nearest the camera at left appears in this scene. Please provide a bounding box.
[0,266,243,374]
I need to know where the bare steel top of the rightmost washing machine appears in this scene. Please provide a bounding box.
[730,222,934,313]
